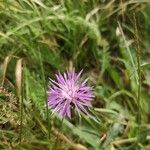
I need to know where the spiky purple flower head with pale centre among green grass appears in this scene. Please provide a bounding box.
[48,70,94,118]
